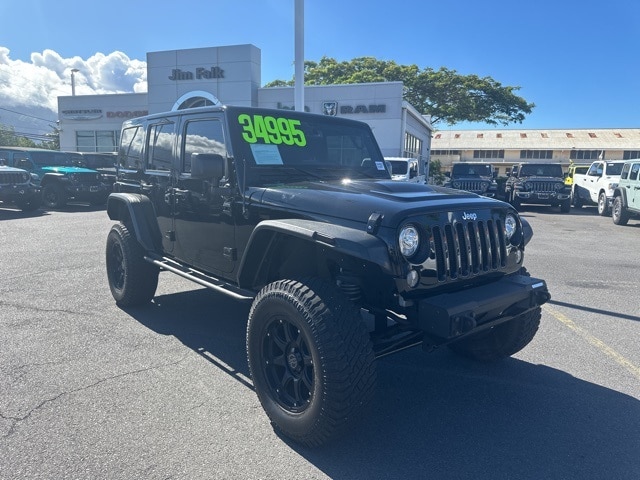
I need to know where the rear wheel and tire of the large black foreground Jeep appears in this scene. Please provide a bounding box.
[105,223,160,307]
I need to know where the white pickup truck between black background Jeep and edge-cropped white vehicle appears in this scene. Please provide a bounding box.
[571,160,624,216]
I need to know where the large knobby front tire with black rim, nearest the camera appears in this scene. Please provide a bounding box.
[247,278,376,447]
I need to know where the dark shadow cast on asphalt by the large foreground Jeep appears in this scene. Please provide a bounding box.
[119,289,640,480]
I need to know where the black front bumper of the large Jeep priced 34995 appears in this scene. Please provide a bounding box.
[418,275,551,341]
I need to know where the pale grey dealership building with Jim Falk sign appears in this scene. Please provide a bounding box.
[58,45,433,165]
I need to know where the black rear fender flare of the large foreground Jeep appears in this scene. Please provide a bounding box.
[107,193,162,253]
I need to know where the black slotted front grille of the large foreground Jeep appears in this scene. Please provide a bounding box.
[431,220,507,281]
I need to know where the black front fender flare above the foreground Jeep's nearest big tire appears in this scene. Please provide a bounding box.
[238,219,398,286]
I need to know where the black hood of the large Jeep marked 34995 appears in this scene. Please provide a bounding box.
[250,180,505,227]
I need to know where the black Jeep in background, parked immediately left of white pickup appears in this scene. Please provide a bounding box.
[504,163,571,213]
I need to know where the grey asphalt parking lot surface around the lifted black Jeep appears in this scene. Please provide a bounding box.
[0,205,640,480]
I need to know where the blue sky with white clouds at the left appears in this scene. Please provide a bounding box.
[0,0,640,139]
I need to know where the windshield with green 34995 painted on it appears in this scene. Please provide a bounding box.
[229,108,388,186]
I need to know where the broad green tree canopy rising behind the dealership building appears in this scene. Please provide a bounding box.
[265,57,535,125]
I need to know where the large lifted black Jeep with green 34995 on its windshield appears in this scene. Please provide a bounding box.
[106,107,550,446]
